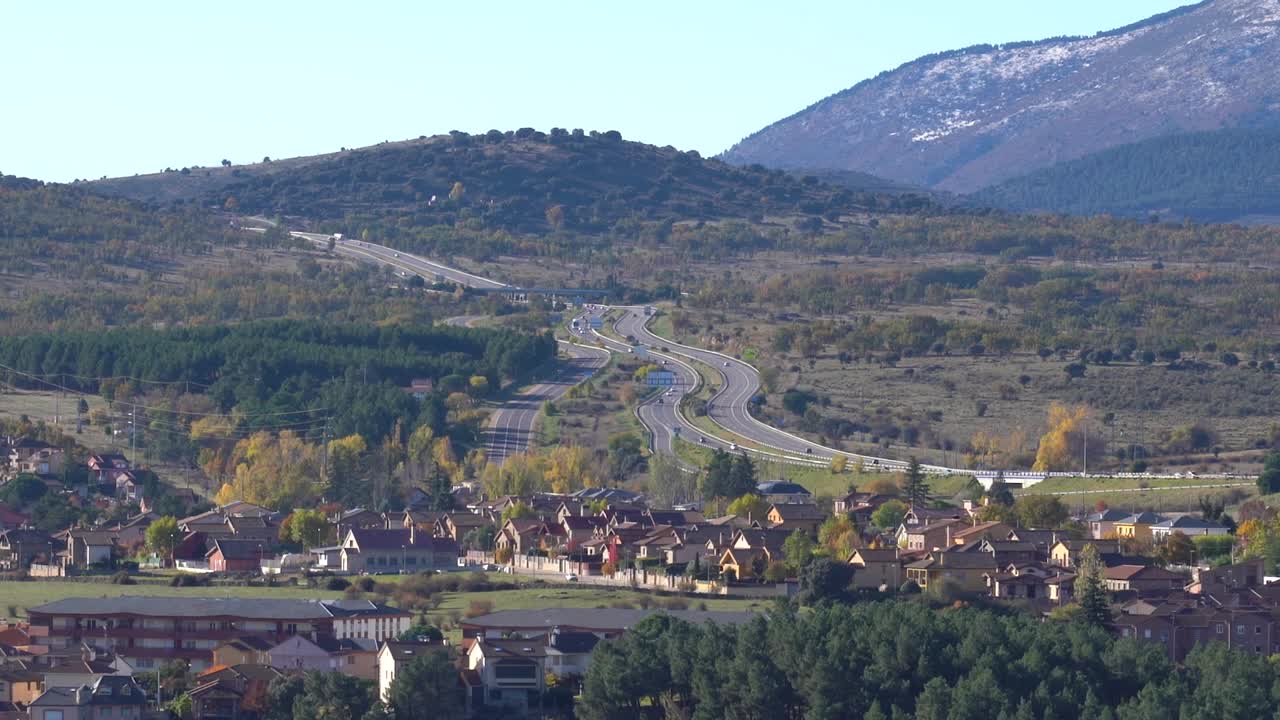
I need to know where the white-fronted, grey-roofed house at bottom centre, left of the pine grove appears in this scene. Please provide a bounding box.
[462,638,547,716]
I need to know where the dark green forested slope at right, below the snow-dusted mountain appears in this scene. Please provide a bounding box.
[966,129,1280,222]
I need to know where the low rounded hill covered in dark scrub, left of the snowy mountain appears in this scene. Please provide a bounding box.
[86,128,928,233]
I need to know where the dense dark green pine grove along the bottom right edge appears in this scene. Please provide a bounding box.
[577,601,1280,720]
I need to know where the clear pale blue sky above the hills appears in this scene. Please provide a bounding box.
[0,0,1190,182]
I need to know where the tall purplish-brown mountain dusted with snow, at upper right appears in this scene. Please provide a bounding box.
[722,0,1280,192]
